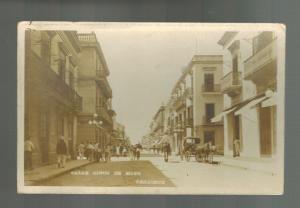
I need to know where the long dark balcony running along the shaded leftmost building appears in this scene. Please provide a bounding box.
[26,51,82,111]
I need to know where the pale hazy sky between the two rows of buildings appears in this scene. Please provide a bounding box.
[95,24,224,143]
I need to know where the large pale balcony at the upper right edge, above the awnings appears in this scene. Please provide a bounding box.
[244,39,277,84]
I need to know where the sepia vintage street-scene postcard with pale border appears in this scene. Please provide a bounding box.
[17,22,285,195]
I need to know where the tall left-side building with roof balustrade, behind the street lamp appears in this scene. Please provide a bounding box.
[77,33,115,149]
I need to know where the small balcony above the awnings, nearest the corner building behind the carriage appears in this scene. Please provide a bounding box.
[221,71,242,97]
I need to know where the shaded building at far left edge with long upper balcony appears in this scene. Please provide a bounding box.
[25,30,82,166]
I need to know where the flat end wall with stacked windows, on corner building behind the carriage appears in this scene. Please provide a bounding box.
[189,55,224,153]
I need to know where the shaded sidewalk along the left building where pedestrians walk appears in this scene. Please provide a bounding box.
[24,160,91,185]
